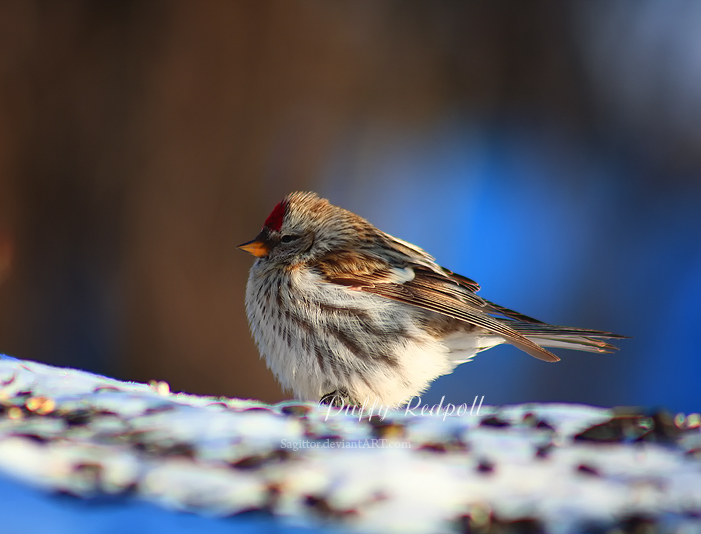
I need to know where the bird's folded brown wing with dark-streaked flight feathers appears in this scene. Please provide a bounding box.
[314,251,560,362]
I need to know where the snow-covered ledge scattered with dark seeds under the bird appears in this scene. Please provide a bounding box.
[0,357,701,533]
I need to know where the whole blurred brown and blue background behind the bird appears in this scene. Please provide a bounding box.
[0,0,701,412]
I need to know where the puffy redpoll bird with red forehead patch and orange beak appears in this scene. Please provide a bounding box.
[239,193,623,405]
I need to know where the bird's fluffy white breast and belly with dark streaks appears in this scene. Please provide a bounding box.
[246,264,460,405]
